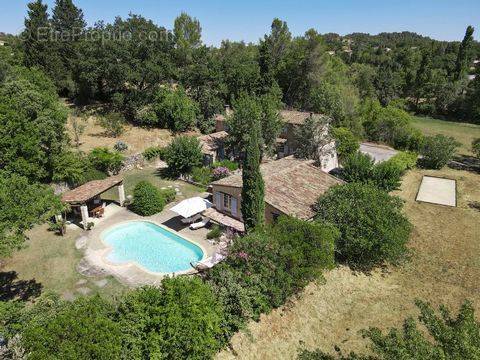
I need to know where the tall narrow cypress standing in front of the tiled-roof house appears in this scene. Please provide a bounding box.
[242,107,265,232]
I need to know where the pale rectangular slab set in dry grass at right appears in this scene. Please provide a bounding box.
[417,176,457,206]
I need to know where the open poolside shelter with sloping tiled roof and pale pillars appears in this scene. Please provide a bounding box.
[62,176,125,228]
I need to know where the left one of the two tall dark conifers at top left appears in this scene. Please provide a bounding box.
[22,0,51,70]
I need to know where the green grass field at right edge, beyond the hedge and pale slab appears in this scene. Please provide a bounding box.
[413,116,480,155]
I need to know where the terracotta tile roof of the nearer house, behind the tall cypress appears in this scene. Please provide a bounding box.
[212,156,344,219]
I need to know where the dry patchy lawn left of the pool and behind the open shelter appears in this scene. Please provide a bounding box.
[0,168,205,299]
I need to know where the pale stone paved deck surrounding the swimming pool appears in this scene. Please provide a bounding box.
[82,203,217,287]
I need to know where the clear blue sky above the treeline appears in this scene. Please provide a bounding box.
[0,0,480,45]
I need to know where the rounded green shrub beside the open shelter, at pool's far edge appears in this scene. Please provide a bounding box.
[130,181,165,216]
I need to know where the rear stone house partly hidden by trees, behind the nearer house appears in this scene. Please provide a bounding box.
[215,109,338,172]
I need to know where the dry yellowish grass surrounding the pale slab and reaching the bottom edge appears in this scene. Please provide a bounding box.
[218,169,480,359]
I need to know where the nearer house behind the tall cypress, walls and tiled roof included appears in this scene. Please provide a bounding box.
[204,156,344,231]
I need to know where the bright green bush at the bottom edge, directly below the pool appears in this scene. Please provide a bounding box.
[119,277,224,359]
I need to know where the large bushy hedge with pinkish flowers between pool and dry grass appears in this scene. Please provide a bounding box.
[207,217,338,335]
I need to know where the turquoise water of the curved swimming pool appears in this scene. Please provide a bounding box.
[103,221,203,273]
